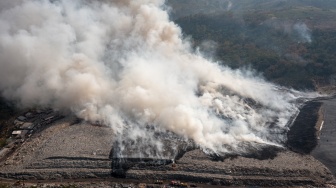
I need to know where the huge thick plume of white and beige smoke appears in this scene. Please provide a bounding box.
[0,0,316,156]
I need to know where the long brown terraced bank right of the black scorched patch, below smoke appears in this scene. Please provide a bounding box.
[126,150,333,186]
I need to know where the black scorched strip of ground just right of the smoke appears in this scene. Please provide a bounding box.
[286,101,322,154]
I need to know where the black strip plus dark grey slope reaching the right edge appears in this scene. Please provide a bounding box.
[287,97,336,176]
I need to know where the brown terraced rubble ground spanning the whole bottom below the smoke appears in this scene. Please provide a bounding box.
[0,106,335,187]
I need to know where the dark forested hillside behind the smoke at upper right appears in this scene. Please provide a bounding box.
[169,0,336,89]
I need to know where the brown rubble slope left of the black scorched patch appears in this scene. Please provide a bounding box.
[0,118,112,180]
